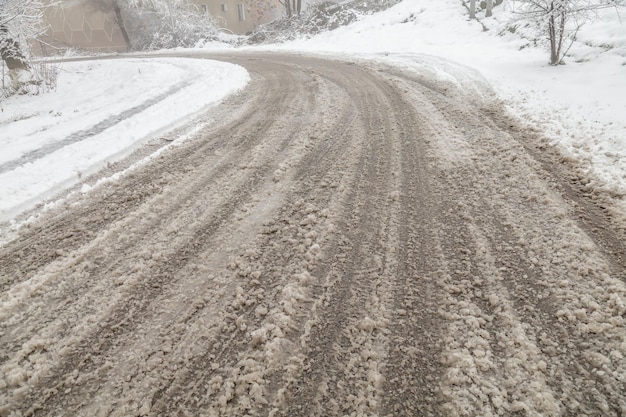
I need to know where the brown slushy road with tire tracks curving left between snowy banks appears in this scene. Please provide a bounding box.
[0,54,626,417]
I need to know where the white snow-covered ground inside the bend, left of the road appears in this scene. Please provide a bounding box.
[0,58,249,222]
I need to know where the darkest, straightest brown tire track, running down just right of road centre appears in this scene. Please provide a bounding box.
[381,80,441,416]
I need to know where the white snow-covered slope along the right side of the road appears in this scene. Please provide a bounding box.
[270,0,626,213]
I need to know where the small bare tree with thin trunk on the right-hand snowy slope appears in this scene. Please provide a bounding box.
[517,0,618,65]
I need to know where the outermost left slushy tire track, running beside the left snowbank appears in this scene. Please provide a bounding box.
[0,58,288,286]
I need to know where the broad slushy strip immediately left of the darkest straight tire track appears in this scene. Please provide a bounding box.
[272,66,397,415]
